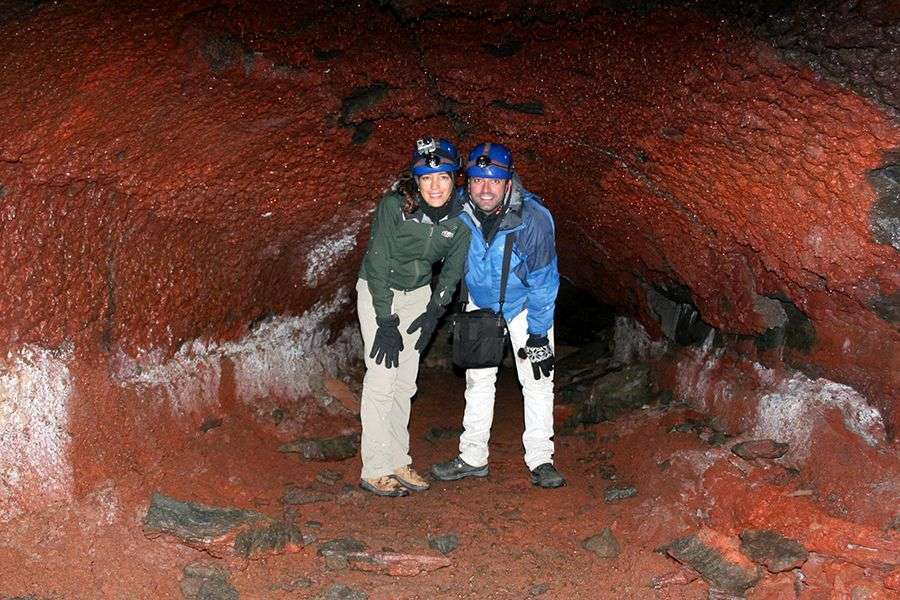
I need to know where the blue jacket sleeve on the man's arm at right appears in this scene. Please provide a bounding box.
[521,202,559,335]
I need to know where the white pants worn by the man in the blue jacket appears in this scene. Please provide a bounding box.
[459,308,553,470]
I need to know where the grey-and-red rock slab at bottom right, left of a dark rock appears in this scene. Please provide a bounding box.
[667,528,761,593]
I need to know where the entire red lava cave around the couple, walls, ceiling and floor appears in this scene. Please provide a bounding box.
[0,0,900,600]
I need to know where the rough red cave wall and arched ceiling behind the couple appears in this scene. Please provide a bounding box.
[0,0,900,520]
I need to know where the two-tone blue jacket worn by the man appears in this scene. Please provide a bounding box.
[459,176,559,335]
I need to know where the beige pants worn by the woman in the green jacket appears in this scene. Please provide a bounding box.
[356,279,431,479]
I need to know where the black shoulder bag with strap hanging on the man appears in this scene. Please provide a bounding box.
[453,233,516,369]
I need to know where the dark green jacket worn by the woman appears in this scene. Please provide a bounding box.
[359,192,471,318]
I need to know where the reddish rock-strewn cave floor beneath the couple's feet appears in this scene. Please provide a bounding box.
[0,322,898,600]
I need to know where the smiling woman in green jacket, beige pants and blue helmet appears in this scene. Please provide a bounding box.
[356,138,470,496]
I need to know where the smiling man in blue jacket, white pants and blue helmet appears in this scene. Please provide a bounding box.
[431,143,566,488]
